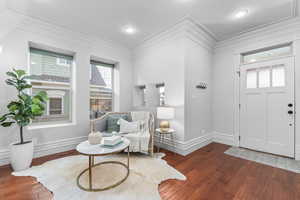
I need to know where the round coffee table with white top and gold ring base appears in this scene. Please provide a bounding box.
[76,138,130,192]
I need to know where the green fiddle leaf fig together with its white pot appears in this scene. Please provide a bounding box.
[0,69,48,171]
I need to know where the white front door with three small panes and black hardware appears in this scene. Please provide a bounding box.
[240,57,295,157]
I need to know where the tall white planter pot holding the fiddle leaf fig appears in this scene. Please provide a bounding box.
[10,141,33,171]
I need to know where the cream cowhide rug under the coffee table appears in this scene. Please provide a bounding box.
[12,153,186,200]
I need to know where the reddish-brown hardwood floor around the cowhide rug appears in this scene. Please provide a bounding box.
[0,143,300,200]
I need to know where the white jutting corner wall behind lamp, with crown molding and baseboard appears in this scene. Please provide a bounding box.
[134,19,214,155]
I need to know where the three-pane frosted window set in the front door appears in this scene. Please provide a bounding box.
[246,65,286,89]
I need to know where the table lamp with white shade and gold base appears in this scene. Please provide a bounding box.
[157,107,175,132]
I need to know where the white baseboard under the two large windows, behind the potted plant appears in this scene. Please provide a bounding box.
[0,136,87,166]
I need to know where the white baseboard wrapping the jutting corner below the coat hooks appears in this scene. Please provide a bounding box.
[154,133,212,156]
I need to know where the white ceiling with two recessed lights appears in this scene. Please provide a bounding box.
[3,0,296,47]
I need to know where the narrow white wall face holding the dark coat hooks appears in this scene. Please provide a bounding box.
[185,39,212,140]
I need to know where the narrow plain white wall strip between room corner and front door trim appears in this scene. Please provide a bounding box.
[212,50,235,143]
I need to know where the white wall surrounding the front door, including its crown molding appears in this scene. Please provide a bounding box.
[212,18,300,159]
